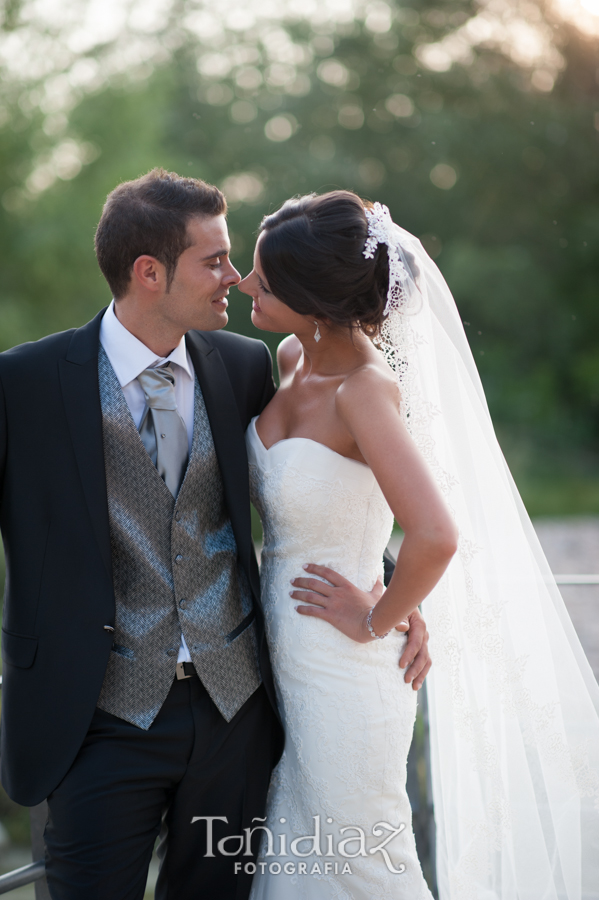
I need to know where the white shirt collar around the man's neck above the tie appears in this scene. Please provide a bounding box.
[100,300,193,387]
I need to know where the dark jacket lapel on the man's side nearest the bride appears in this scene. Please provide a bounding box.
[187,332,252,582]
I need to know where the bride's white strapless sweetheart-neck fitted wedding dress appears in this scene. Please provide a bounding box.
[246,419,432,900]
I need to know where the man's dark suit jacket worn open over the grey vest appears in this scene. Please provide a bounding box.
[0,311,280,806]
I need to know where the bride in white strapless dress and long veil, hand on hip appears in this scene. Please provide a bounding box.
[240,191,599,900]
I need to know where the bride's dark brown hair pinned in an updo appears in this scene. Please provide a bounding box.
[259,191,389,337]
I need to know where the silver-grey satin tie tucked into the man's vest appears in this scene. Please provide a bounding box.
[137,365,189,497]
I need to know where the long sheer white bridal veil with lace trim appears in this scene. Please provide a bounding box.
[364,204,599,900]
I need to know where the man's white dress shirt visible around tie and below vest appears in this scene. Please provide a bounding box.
[100,300,195,662]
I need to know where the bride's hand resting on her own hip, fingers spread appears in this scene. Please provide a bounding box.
[289,564,385,644]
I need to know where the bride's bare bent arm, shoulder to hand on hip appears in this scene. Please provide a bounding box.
[294,367,457,642]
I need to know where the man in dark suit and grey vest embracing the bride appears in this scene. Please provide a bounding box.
[0,170,430,900]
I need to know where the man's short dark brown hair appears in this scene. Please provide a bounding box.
[95,169,227,300]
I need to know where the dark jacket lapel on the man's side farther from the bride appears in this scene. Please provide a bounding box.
[59,310,112,577]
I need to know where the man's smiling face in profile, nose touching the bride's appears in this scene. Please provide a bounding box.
[161,216,241,332]
